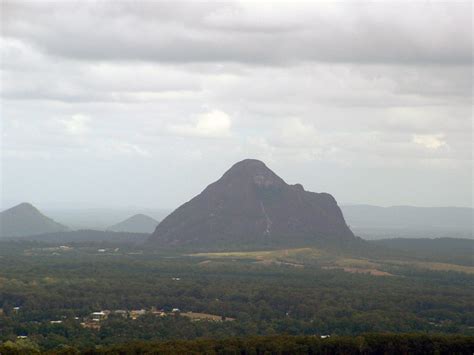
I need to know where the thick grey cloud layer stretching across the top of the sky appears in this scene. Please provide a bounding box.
[3,2,472,65]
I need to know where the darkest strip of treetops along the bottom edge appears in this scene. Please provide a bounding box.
[0,334,474,355]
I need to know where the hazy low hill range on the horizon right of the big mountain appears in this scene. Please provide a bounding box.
[341,205,474,239]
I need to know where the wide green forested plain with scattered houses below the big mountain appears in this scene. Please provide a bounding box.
[0,242,474,352]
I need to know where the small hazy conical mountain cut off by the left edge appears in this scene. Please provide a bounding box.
[0,203,68,237]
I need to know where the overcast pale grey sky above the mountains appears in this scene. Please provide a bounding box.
[0,1,473,208]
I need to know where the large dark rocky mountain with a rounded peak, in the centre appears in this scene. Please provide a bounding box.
[149,159,356,247]
